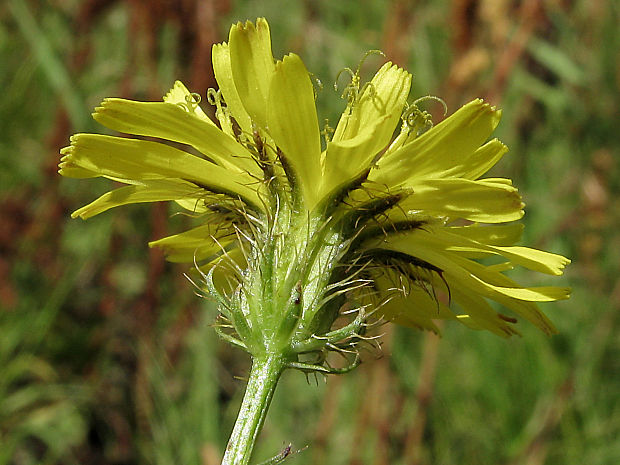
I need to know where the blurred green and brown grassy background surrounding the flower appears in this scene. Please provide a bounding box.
[0,0,620,465]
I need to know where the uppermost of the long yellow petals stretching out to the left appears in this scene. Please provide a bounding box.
[93,98,259,176]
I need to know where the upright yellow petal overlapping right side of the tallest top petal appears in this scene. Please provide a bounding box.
[267,54,321,205]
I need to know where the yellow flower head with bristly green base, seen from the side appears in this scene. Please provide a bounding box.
[60,19,569,358]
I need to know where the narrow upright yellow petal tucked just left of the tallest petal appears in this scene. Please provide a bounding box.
[211,42,252,134]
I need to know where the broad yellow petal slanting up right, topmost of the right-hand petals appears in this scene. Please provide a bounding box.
[370,99,501,186]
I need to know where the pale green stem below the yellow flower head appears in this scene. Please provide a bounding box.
[222,354,285,465]
